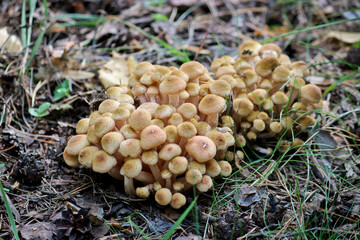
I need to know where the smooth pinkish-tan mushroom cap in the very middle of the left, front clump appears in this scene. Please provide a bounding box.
[140,125,166,150]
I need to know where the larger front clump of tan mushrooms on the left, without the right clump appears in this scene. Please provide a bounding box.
[63,62,235,208]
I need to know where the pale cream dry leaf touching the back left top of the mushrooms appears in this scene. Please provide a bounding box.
[99,52,129,88]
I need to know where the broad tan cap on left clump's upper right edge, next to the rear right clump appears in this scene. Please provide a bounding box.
[199,94,226,115]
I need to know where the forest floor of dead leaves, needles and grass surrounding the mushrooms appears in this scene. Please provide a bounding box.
[0,0,360,240]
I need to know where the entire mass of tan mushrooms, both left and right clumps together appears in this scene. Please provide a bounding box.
[63,41,322,209]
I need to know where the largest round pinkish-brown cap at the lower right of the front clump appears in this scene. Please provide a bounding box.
[185,136,216,163]
